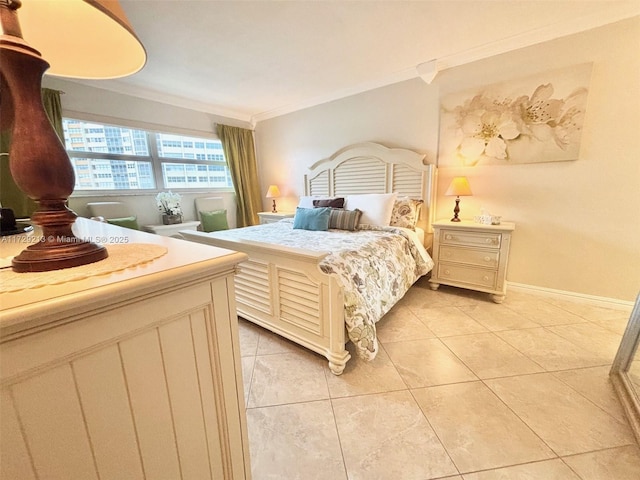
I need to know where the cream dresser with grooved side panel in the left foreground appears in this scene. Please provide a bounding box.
[0,218,251,480]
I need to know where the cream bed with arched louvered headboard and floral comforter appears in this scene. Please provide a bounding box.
[180,143,436,375]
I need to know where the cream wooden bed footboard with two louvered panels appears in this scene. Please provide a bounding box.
[180,231,351,375]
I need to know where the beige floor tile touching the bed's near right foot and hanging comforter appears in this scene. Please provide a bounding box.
[325,343,407,398]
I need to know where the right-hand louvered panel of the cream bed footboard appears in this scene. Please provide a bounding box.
[277,268,323,336]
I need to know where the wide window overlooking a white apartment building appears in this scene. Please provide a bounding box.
[62,118,233,192]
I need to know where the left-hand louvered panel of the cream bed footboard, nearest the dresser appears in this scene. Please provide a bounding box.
[235,260,273,315]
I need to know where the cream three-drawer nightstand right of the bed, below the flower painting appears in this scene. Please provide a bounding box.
[429,220,516,303]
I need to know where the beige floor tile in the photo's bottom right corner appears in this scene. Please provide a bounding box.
[563,445,640,480]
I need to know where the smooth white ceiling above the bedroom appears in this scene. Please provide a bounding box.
[67,0,640,122]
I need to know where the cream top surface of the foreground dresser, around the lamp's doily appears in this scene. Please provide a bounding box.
[0,218,246,327]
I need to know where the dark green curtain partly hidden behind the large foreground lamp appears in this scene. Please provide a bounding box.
[0,88,64,218]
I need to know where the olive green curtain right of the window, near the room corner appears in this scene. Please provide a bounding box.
[218,125,262,227]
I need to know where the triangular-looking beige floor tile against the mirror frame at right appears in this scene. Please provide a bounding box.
[554,365,627,423]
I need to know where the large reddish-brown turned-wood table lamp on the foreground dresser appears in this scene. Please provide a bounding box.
[0,0,146,272]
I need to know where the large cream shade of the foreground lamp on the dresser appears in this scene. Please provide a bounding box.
[19,0,147,79]
